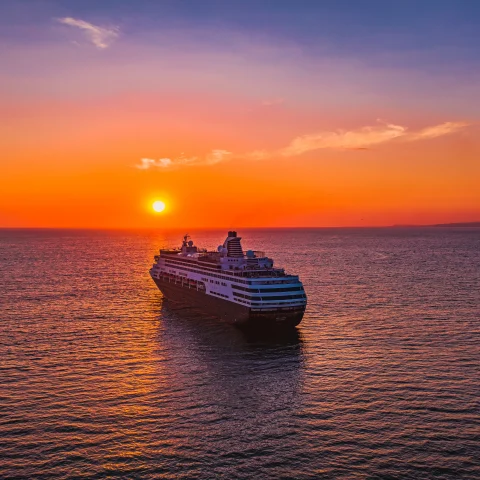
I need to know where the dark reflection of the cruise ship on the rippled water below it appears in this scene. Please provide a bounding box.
[159,301,305,416]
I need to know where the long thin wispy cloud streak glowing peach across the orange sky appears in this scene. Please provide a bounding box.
[136,122,469,170]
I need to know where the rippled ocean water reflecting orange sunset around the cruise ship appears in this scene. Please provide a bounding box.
[0,228,480,479]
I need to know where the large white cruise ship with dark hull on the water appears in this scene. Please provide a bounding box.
[150,232,307,330]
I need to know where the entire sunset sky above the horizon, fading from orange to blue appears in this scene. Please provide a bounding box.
[0,1,480,228]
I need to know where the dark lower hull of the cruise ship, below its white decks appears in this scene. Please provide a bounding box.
[153,278,305,331]
